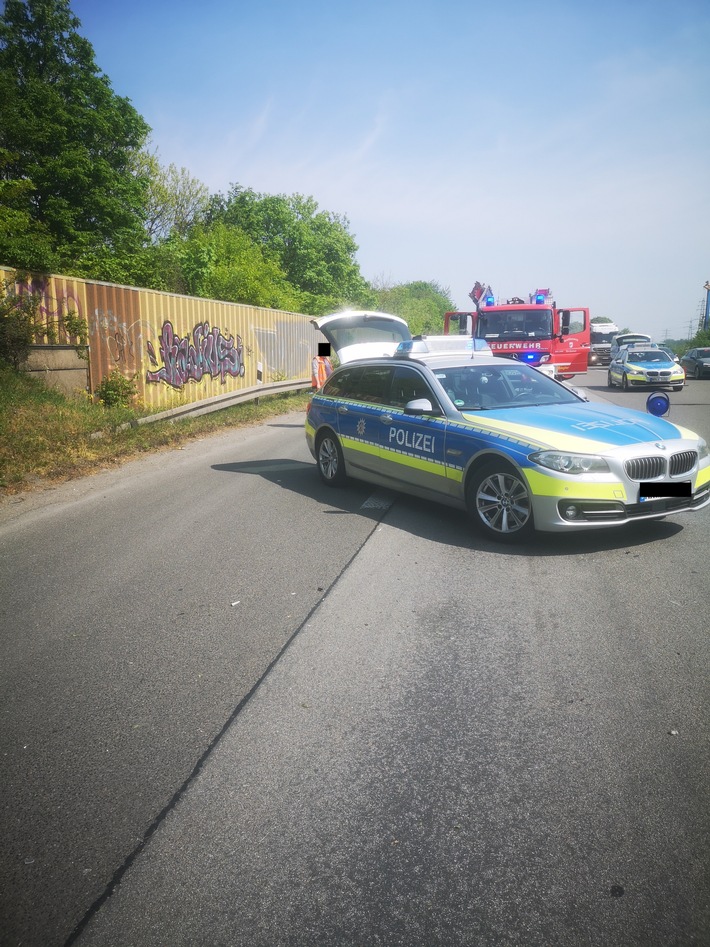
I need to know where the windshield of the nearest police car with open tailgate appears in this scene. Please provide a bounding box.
[434,362,582,411]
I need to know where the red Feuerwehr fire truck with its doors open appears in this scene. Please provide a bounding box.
[444,283,590,378]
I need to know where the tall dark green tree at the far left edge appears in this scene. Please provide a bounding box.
[0,0,149,279]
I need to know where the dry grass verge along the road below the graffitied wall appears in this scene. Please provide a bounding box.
[0,364,310,496]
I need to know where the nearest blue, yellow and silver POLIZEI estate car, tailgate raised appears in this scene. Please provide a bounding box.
[305,313,710,541]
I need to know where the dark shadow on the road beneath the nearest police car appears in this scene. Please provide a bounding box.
[212,458,683,558]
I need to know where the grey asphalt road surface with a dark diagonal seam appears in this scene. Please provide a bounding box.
[0,371,710,947]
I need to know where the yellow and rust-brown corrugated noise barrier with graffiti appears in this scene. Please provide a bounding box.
[0,267,323,417]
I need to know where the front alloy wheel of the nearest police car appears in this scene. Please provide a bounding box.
[467,461,533,542]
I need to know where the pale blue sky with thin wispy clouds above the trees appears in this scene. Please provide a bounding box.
[71,0,710,338]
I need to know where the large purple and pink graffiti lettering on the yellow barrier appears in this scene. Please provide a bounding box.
[146,320,245,389]
